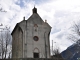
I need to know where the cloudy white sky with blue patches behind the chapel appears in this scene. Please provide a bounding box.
[0,0,80,52]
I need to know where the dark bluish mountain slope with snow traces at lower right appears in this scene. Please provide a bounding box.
[61,44,80,60]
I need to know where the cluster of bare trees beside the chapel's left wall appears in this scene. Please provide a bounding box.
[0,27,11,59]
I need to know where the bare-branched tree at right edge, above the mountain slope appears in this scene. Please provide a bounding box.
[68,22,80,43]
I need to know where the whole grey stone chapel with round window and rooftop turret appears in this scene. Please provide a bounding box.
[11,7,51,58]
